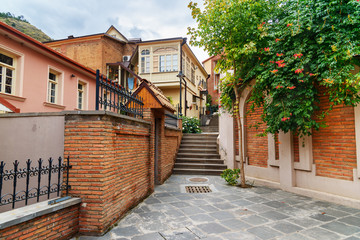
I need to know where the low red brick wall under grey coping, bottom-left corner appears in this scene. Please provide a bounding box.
[0,204,80,240]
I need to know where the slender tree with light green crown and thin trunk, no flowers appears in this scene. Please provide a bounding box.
[189,0,276,187]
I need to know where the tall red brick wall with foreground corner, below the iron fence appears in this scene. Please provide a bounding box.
[64,114,153,235]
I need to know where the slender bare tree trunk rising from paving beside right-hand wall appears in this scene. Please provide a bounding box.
[234,86,246,187]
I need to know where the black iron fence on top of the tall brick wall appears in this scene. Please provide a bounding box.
[96,70,144,118]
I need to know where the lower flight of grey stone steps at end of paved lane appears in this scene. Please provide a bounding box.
[174,133,226,175]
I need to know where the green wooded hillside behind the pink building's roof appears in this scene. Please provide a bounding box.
[0,12,51,42]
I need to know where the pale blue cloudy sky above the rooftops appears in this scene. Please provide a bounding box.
[0,0,208,61]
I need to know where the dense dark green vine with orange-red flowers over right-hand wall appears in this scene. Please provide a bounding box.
[249,0,360,135]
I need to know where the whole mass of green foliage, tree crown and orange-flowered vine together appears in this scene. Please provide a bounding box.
[189,0,360,136]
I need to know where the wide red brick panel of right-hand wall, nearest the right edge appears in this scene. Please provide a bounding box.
[312,89,356,181]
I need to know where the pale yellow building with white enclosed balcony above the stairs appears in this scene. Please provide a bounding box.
[137,38,208,118]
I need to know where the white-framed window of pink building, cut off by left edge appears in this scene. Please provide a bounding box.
[0,53,15,94]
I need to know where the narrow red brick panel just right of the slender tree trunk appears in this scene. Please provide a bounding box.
[244,99,268,167]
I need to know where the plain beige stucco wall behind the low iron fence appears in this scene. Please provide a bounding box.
[0,114,64,212]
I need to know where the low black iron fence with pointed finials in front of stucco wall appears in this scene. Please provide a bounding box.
[0,157,71,208]
